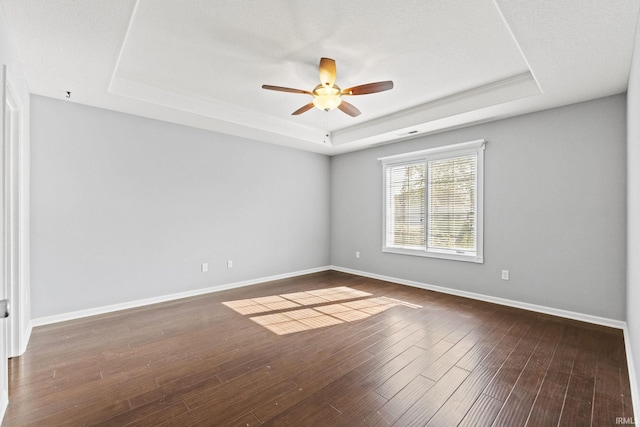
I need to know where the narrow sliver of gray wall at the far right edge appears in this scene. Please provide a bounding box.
[627,10,640,404]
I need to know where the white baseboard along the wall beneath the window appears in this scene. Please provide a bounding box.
[331,265,626,329]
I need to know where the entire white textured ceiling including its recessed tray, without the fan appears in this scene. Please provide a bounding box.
[2,0,640,154]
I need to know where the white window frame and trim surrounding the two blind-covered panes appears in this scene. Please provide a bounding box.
[378,139,486,264]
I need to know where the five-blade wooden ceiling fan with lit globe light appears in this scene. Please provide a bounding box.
[262,58,393,117]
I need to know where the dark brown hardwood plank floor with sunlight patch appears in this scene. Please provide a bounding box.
[3,271,633,426]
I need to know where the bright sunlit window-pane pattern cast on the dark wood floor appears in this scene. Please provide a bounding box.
[223,286,421,335]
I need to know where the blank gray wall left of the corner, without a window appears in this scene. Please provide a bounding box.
[31,96,330,318]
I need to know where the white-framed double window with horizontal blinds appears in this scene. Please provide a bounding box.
[379,140,485,263]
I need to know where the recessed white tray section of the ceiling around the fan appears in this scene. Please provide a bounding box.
[110,0,529,143]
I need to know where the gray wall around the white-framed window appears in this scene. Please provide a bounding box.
[331,95,626,320]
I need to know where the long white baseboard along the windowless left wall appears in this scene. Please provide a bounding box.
[31,266,330,327]
